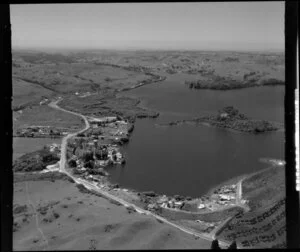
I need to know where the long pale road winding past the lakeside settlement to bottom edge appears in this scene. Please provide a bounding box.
[48,99,229,247]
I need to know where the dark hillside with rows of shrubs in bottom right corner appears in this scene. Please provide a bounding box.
[218,166,286,248]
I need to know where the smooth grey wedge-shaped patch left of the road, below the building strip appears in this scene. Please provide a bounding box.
[13,137,61,160]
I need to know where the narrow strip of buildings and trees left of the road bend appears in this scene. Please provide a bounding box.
[16,126,68,137]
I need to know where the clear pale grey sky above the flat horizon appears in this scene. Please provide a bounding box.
[10,2,284,51]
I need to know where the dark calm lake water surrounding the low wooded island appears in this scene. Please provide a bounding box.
[110,75,284,197]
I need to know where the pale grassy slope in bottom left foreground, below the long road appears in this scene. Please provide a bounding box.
[13,175,211,251]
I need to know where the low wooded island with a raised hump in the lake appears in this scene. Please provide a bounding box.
[159,106,284,134]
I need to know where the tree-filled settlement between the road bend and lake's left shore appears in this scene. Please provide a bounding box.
[63,116,133,182]
